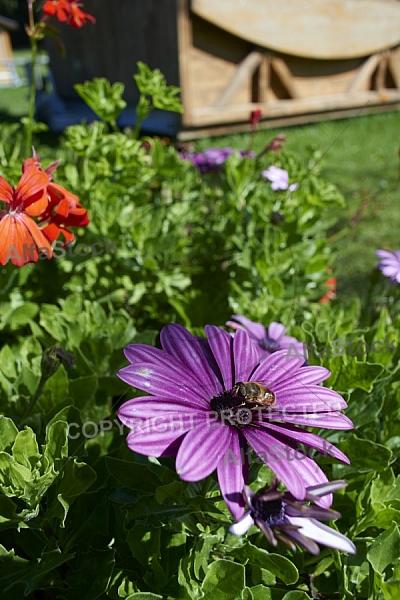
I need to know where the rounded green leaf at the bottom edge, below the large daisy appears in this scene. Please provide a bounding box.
[202,559,245,600]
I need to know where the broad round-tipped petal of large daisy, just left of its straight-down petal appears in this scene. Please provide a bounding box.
[176,421,233,481]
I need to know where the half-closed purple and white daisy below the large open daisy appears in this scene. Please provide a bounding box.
[229,478,356,554]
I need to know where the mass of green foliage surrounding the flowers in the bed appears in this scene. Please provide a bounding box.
[0,63,400,600]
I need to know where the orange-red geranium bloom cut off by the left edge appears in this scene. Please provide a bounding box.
[0,159,52,267]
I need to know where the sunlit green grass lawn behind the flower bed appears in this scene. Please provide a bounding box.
[0,67,400,300]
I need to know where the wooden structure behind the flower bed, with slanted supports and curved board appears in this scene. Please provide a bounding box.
[43,0,400,139]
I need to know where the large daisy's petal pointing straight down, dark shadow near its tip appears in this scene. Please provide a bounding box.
[217,432,247,519]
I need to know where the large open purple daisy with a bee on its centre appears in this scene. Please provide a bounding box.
[118,324,353,518]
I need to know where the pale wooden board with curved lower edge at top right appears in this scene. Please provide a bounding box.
[192,0,400,59]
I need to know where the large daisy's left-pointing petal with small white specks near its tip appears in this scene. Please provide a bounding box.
[118,363,209,407]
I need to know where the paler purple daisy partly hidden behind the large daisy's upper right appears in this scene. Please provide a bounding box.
[226,315,307,360]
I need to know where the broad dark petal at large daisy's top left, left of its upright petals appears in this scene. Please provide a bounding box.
[160,323,222,398]
